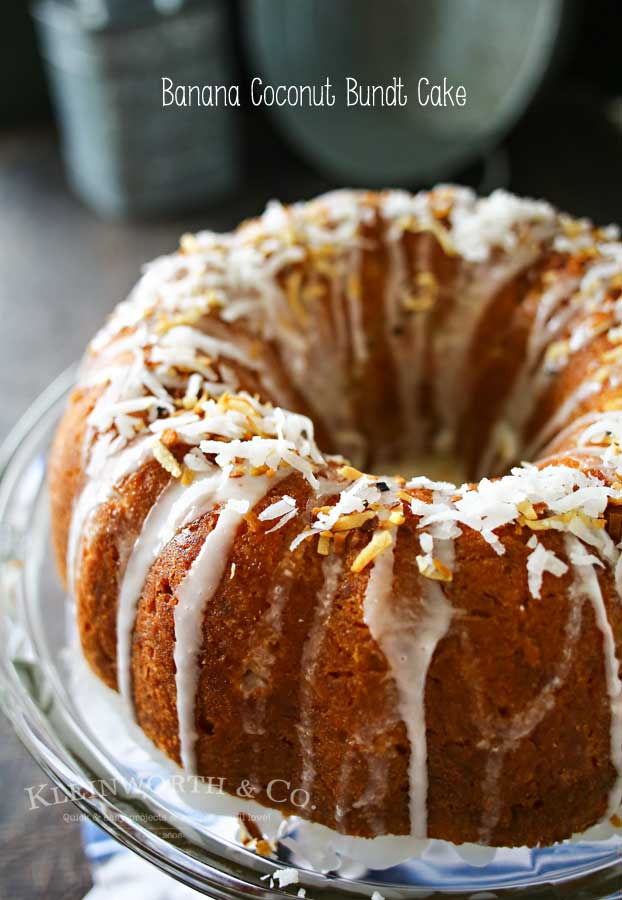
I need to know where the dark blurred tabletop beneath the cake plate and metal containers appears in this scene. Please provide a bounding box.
[0,89,622,900]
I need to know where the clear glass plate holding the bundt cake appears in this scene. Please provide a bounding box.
[0,370,622,900]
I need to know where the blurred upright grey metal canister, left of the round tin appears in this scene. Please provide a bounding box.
[34,0,240,216]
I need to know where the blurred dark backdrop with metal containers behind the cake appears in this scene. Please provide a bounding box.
[0,0,622,898]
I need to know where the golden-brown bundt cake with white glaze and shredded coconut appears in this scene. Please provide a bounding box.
[49,186,622,846]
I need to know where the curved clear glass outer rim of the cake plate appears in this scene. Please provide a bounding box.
[0,366,622,900]
